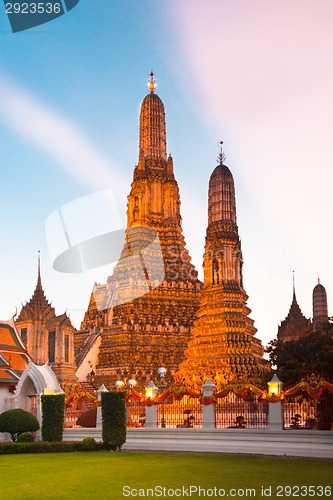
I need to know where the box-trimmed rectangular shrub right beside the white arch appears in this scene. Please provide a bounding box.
[41,394,65,441]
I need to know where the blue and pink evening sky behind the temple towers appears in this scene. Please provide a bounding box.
[0,0,333,345]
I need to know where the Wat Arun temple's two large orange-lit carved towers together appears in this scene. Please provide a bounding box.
[74,73,266,389]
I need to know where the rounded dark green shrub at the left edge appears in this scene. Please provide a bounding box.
[0,408,39,442]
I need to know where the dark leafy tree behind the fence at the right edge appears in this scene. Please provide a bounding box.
[266,323,333,385]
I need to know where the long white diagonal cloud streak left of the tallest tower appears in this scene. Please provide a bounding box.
[0,75,127,191]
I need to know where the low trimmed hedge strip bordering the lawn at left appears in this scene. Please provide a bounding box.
[0,438,104,455]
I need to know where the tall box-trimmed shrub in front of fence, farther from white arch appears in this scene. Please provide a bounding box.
[102,392,126,451]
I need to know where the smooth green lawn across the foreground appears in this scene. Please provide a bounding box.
[0,451,333,500]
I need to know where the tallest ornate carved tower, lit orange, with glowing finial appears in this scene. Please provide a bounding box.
[80,73,202,386]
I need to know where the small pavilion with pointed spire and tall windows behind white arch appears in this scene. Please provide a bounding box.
[15,253,77,384]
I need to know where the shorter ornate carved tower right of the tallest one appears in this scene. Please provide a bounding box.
[176,151,264,389]
